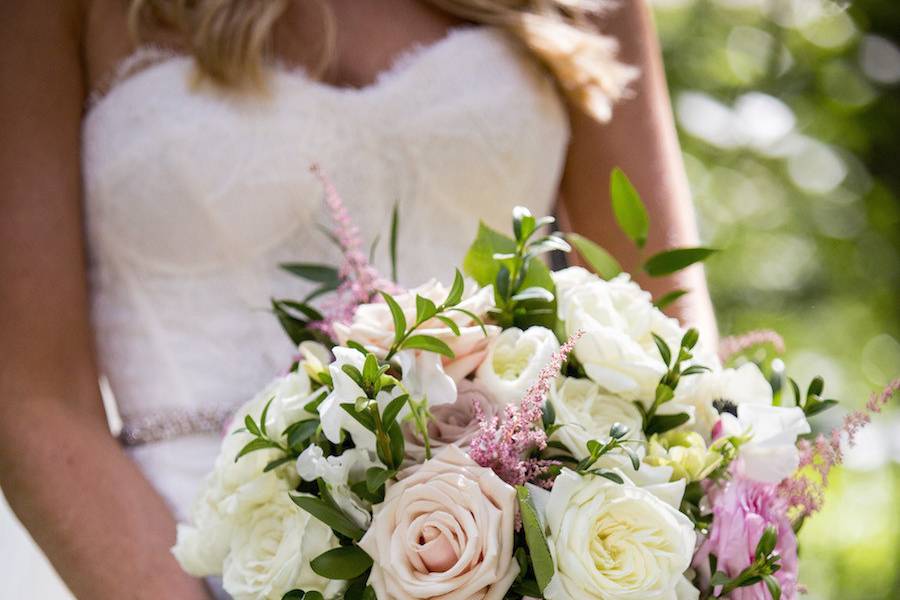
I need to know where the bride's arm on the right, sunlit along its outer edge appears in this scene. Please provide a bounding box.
[560,0,716,339]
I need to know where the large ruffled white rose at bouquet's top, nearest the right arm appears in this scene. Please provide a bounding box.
[560,273,683,402]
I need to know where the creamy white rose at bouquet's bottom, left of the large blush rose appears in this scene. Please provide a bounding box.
[222,493,346,600]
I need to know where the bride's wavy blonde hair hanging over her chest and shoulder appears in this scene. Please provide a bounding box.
[130,0,637,121]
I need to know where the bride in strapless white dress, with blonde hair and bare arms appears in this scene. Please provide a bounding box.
[0,0,713,600]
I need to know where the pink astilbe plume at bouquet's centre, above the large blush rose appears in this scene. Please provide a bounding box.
[469,331,582,488]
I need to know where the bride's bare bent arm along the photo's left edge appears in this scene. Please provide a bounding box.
[0,0,208,599]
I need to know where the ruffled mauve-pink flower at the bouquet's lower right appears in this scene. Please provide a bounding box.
[693,468,799,600]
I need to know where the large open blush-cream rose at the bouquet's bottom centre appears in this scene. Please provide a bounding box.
[359,446,519,600]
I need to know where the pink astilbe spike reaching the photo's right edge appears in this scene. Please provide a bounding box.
[779,378,900,518]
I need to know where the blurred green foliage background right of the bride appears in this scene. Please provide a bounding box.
[653,0,900,600]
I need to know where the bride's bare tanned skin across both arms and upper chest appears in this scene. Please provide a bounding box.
[0,0,714,600]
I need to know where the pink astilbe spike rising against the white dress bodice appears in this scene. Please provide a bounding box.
[310,164,397,337]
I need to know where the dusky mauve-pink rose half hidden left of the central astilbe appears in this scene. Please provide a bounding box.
[403,379,499,463]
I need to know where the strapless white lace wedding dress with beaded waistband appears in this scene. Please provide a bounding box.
[0,28,568,598]
